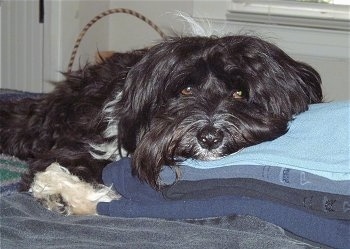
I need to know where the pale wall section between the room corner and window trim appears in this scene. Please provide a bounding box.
[108,0,193,51]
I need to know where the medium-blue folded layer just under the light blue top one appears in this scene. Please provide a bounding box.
[159,165,350,196]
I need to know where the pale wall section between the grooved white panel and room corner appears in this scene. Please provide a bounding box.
[43,0,109,92]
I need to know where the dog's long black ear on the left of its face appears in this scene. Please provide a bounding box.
[118,42,186,153]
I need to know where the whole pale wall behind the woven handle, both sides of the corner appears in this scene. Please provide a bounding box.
[43,0,192,92]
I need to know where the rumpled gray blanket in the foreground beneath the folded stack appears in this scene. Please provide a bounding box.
[0,193,315,249]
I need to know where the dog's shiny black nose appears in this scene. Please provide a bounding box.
[197,126,224,149]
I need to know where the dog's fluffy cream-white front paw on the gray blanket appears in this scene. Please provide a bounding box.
[29,163,120,215]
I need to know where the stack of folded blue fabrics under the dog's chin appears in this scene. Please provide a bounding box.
[98,102,350,248]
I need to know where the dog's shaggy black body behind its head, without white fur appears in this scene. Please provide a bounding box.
[0,50,144,190]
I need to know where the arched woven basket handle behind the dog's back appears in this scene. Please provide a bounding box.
[68,8,166,72]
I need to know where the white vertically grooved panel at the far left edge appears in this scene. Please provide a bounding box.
[0,0,43,92]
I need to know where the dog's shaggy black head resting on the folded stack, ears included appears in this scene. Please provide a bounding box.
[118,36,322,186]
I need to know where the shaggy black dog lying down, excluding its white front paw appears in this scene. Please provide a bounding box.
[0,36,322,214]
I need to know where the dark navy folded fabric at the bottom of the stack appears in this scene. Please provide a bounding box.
[97,159,350,249]
